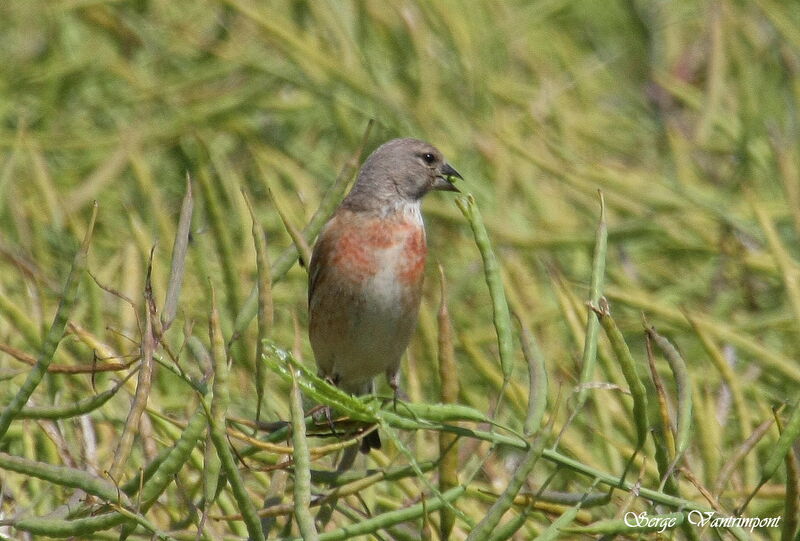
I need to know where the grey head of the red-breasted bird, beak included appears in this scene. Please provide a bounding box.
[344,138,462,210]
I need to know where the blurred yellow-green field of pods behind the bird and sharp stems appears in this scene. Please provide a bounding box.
[0,0,800,536]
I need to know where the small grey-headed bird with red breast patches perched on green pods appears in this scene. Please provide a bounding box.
[308,138,463,462]
